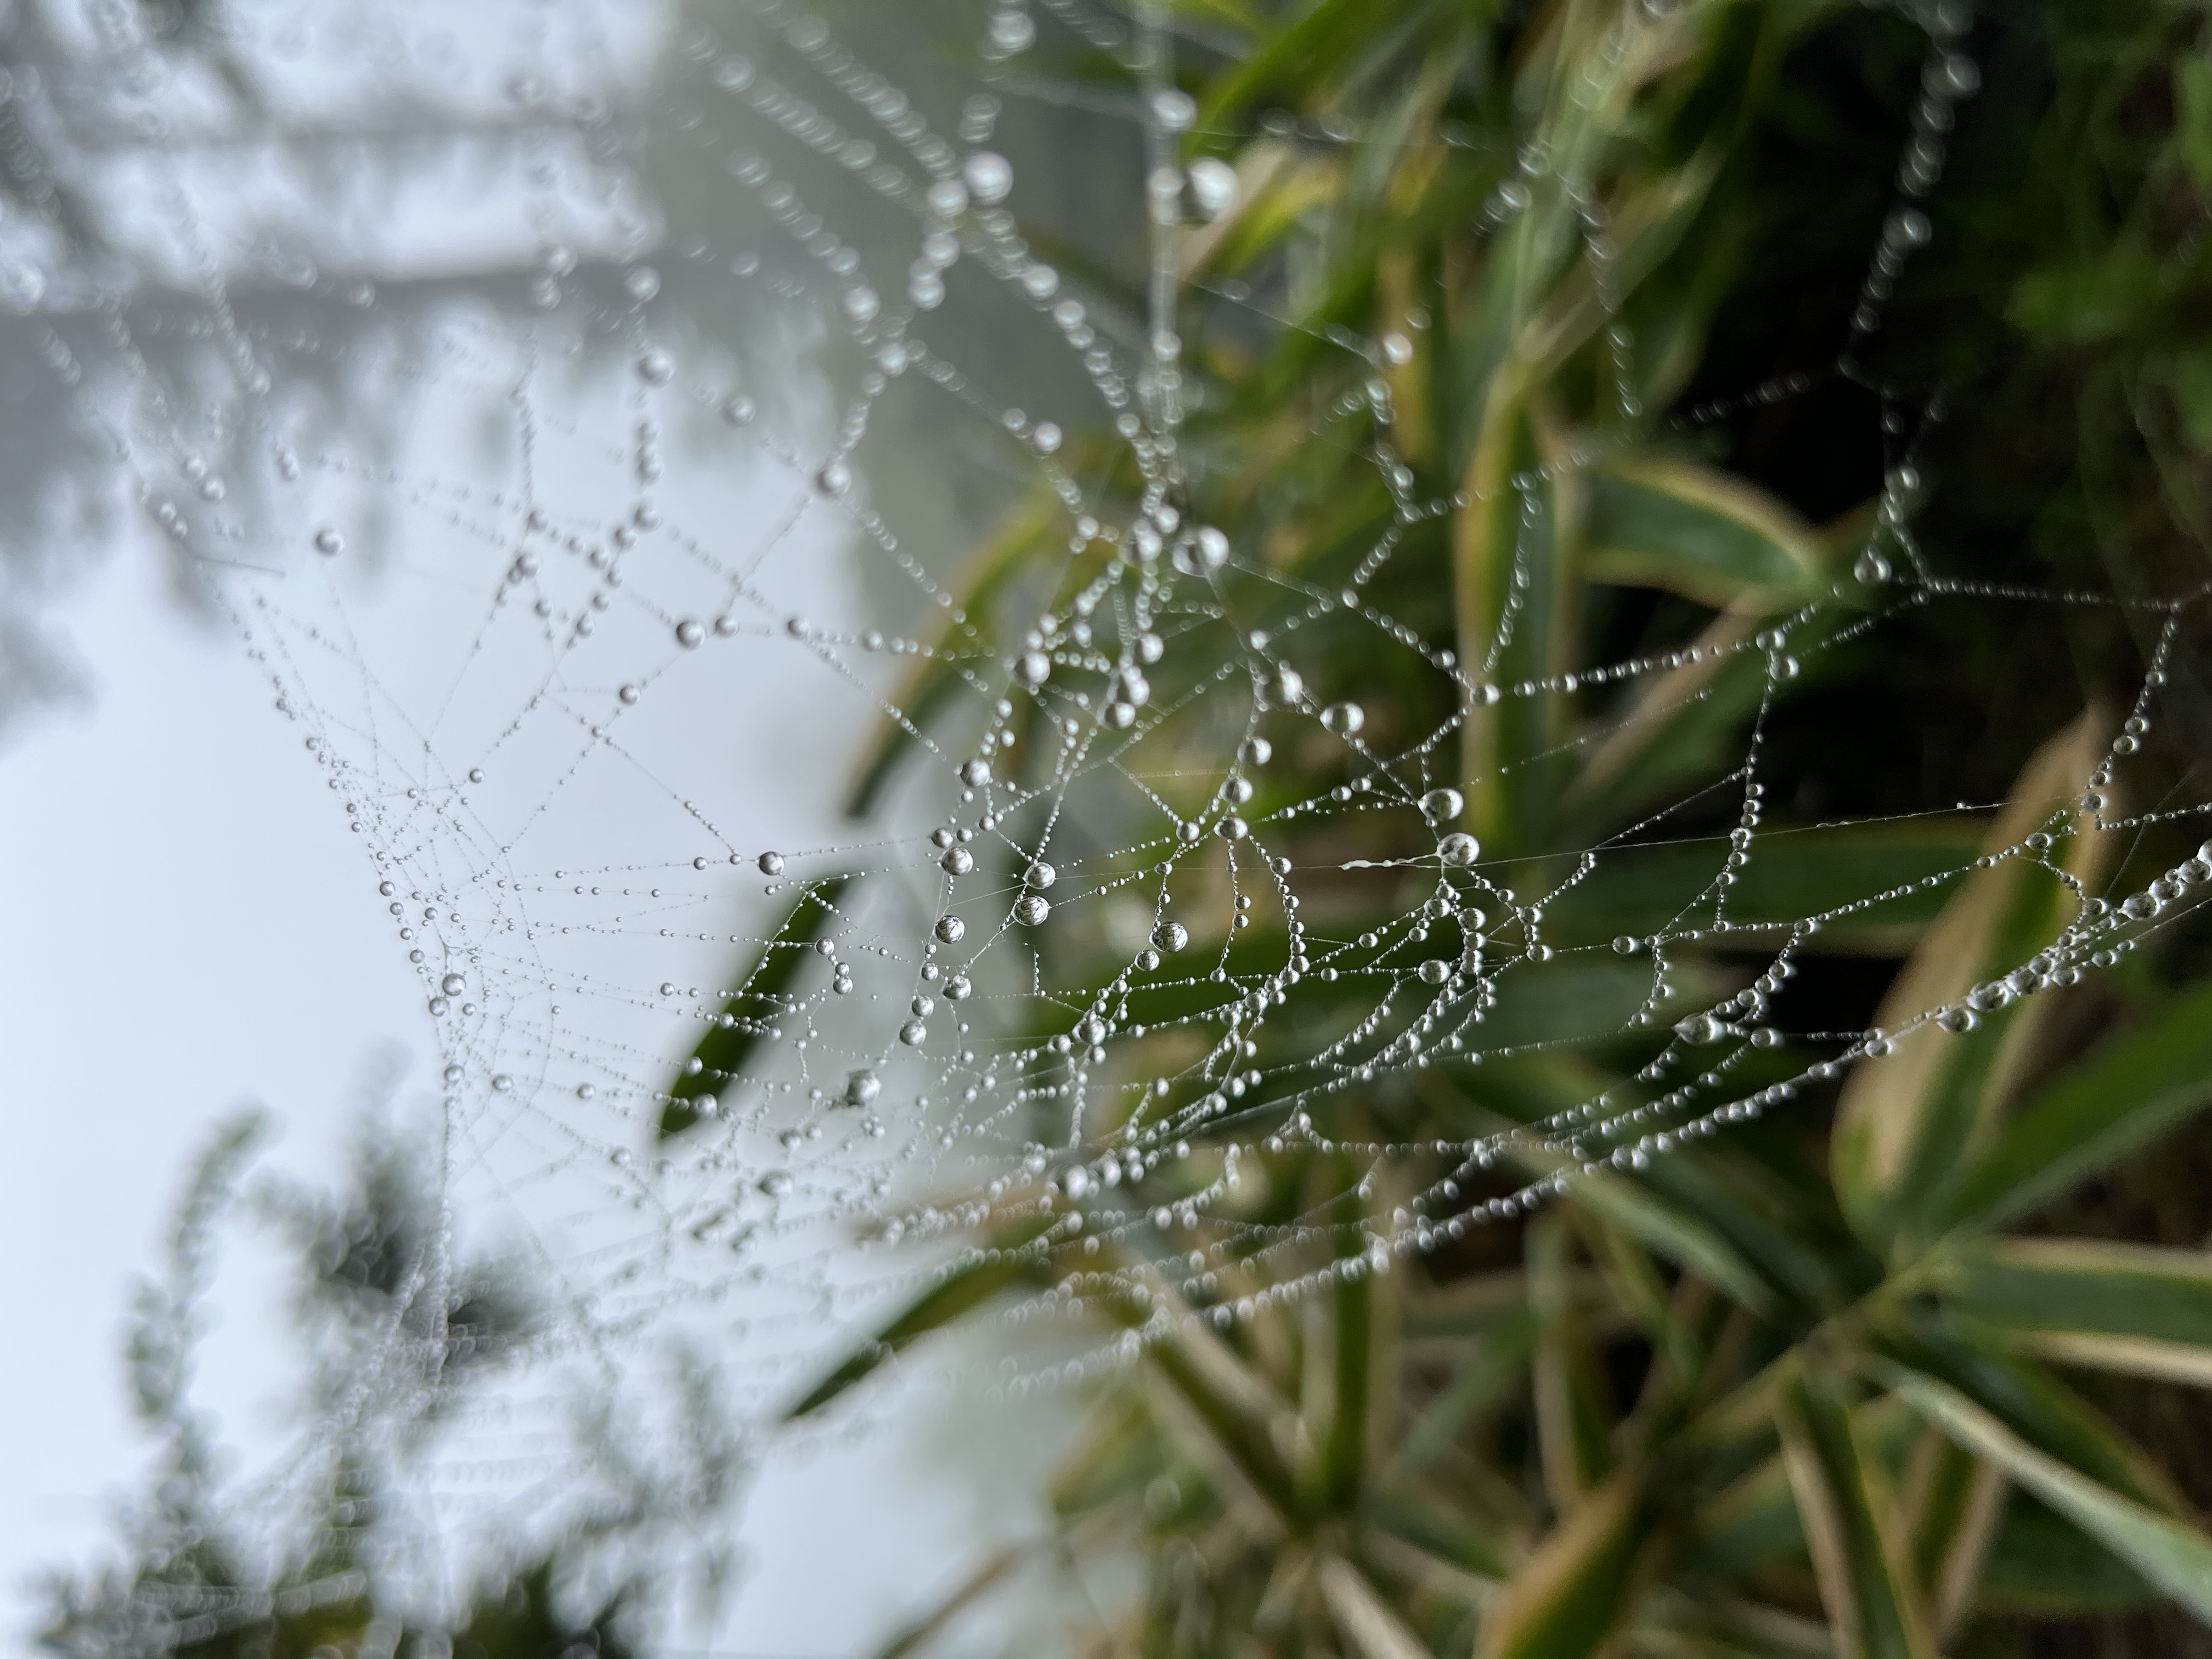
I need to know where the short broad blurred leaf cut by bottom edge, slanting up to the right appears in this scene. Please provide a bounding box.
[1475,1464,1646,1659]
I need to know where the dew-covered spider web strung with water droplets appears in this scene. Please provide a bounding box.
[26,0,2212,1637]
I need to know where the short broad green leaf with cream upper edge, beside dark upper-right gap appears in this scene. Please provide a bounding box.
[1582,456,1822,611]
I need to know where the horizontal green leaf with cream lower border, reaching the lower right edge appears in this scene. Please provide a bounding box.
[1933,1239,2212,1387]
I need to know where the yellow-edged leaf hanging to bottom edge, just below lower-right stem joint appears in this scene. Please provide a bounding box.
[1774,1376,1936,1659]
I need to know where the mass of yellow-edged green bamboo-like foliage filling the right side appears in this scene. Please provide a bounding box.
[770,0,2212,1659]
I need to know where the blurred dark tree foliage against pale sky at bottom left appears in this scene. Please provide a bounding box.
[38,1117,654,1659]
